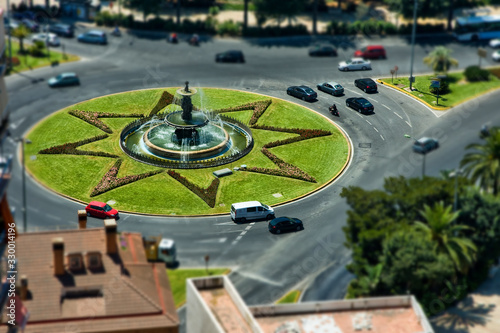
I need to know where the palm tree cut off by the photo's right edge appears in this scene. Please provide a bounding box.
[460,127,500,196]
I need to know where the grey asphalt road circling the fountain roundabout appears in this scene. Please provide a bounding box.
[4,27,500,312]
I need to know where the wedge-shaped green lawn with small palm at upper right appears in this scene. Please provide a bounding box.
[381,73,500,107]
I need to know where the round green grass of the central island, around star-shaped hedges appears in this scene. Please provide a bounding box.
[25,88,349,215]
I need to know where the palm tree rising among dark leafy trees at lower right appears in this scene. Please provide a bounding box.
[414,201,477,273]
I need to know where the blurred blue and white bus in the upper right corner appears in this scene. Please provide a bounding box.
[454,15,500,42]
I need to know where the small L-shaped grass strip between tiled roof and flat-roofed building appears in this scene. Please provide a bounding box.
[167,268,230,307]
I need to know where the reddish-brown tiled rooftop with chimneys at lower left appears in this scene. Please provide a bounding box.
[2,224,179,333]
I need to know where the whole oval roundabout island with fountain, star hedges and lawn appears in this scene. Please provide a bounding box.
[26,85,351,216]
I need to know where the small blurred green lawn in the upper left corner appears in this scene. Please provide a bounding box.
[5,39,80,73]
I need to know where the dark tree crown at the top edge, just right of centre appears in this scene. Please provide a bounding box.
[254,0,307,26]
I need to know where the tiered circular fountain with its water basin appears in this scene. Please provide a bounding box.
[120,82,253,168]
